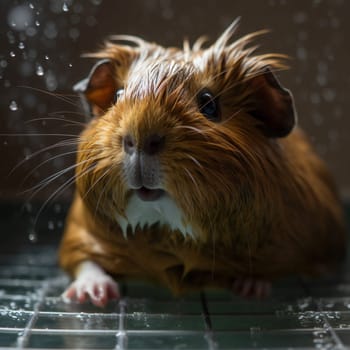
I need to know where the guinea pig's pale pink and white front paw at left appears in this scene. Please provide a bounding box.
[62,273,120,307]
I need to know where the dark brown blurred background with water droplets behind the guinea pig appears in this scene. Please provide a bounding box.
[0,0,350,241]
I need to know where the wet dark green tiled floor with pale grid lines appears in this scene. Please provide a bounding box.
[0,202,350,350]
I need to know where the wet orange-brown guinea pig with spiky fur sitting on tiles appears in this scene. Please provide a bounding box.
[59,21,346,306]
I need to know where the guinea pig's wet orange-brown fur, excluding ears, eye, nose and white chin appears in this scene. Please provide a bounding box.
[60,24,345,293]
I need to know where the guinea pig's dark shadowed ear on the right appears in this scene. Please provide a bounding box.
[247,67,297,137]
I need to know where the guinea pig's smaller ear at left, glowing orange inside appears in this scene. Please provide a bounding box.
[73,59,116,116]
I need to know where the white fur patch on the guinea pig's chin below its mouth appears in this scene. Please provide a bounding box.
[116,195,193,236]
